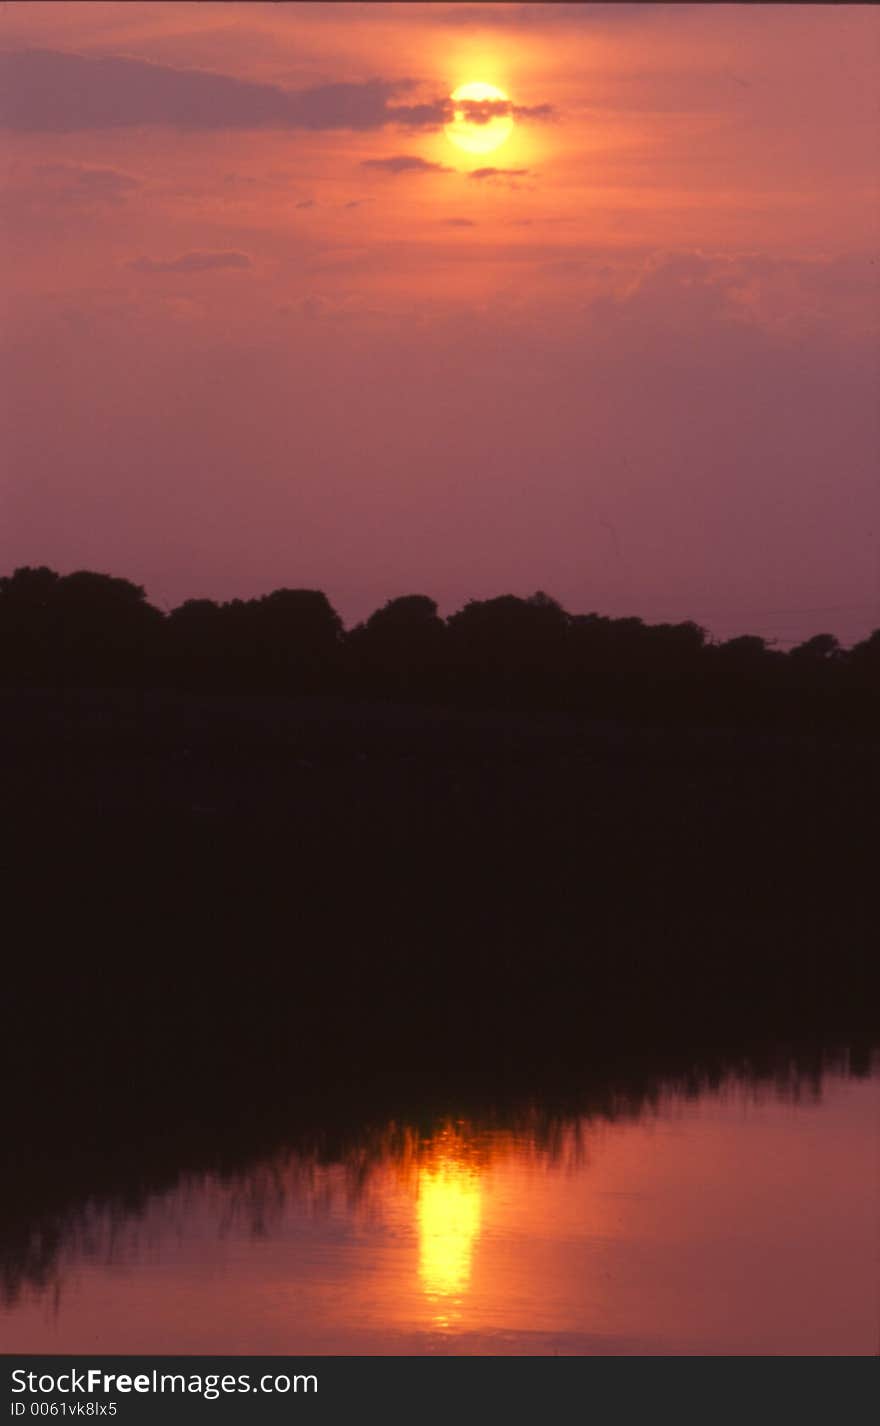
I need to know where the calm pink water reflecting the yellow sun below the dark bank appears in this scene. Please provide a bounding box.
[0,1064,880,1355]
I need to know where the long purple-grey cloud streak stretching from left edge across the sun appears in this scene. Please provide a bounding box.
[0,50,551,134]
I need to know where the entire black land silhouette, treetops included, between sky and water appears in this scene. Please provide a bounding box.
[0,570,880,1306]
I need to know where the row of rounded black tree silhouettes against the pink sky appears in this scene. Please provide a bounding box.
[0,566,880,727]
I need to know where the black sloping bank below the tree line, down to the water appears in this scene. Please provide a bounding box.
[0,690,880,1291]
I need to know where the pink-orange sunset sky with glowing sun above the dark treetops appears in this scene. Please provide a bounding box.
[0,0,880,646]
